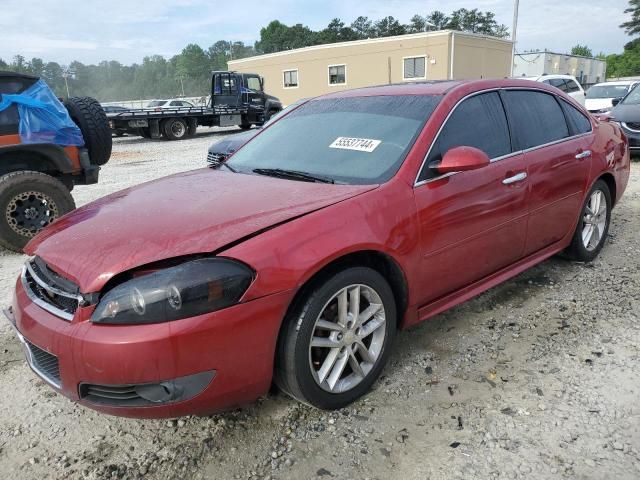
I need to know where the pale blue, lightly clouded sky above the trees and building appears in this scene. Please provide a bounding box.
[0,0,631,64]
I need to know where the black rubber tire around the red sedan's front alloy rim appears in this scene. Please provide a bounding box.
[274,267,396,410]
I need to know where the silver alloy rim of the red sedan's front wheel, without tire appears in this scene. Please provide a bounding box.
[309,284,386,393]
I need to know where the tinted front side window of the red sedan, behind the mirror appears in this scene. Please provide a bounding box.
[418,92,511,181]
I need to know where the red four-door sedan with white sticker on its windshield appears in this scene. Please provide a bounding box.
[7,80,629,417]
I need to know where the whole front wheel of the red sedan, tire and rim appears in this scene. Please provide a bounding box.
[275,267,396,409]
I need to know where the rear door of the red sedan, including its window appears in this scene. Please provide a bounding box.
[503,90,593,255]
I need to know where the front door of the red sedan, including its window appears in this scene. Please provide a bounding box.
[414,91,527,304]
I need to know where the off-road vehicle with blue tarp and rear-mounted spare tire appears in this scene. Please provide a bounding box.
[0,72,111,252]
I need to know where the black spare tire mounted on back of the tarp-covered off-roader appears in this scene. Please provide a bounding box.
[64,97,112,166]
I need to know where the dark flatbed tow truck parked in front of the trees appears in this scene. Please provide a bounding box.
[107,72,282,140]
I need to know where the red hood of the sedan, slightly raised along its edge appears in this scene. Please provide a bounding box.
[25,168,376,293]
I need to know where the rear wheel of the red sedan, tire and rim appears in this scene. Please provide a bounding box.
[566,180,612,262]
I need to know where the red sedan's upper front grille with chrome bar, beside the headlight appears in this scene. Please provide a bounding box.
[22,258,81,320]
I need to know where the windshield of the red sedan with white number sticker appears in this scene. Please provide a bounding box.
[228,95,441,184]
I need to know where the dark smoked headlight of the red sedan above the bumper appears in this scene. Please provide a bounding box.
[91,258,253,325]
